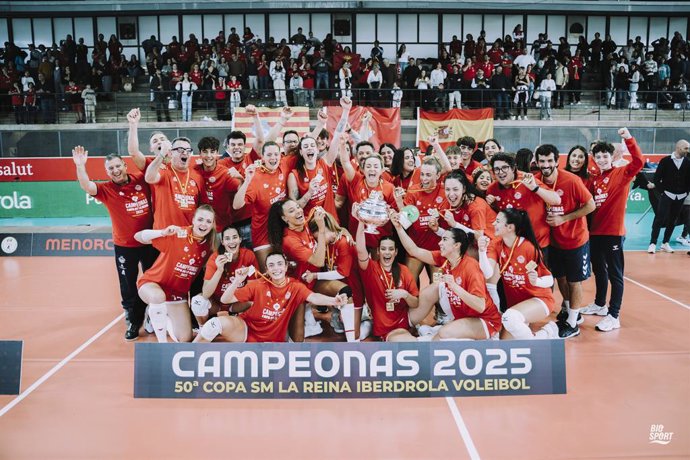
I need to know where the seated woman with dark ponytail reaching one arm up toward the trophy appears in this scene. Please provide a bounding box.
[391,215,501,340]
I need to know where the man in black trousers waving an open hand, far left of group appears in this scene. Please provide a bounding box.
[72,145,158,341]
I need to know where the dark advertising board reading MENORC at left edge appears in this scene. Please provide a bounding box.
[0,233,115,257]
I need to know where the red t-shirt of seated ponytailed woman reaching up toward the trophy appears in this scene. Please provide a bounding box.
[431,251,501,335]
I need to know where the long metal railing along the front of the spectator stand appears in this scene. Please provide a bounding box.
[0,88,690,125]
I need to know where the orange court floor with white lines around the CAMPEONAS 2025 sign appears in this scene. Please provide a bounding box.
[0,252,690,460]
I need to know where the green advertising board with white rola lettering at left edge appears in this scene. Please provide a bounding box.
[0,180,108,218]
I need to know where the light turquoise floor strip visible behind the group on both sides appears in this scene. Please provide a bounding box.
[0,211,690,251]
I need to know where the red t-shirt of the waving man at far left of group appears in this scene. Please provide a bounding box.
[95,171,153,248]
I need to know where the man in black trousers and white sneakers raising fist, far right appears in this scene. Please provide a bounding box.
[580,128,644,332]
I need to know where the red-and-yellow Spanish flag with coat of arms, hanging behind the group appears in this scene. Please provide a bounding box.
[417,109,494,151]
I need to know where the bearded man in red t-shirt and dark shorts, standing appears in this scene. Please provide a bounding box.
[535,144,595,338]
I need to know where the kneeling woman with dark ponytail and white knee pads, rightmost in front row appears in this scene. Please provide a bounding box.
[479,208,558,339]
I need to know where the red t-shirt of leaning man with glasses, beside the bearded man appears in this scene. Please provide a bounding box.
[486,171,551,248]
